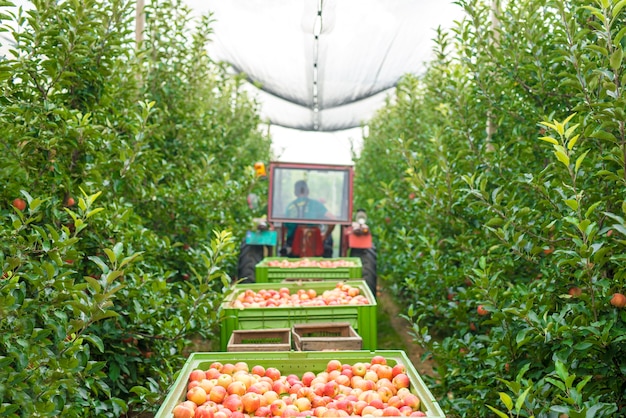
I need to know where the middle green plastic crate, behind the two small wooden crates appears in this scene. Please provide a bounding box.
[220,280,377,351]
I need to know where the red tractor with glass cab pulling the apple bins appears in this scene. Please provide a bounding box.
[238,162,376,294]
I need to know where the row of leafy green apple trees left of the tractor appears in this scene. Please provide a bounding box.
[0,0,269,417]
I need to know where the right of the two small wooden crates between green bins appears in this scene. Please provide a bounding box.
[290,322,363,351]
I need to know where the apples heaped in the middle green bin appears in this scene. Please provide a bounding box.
[230,282,369,309]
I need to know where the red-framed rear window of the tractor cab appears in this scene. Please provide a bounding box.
[268,163,352,224]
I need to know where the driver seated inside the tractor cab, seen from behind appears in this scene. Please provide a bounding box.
[285,180,335,257]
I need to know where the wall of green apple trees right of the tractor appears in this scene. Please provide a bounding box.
[356,0,626,417]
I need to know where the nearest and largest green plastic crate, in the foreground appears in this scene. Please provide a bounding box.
[155,350,446,418]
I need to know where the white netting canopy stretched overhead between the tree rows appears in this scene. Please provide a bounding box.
[188,0,461,131]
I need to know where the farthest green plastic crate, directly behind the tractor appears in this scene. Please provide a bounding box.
[254,257,363,283]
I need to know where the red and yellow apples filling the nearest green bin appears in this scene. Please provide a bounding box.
[173,355,426,418]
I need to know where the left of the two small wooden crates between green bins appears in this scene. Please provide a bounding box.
[227,328,291,352]
